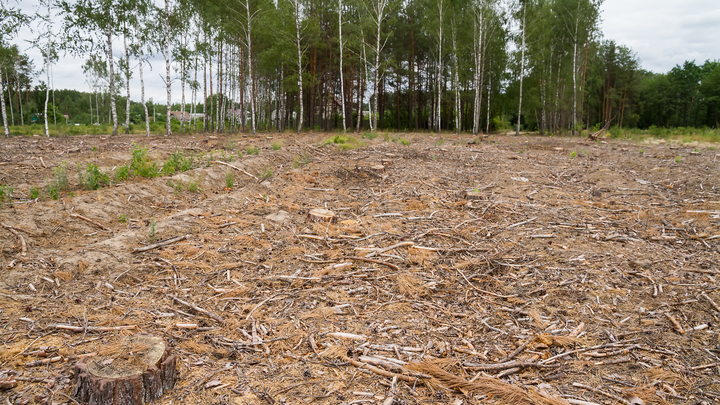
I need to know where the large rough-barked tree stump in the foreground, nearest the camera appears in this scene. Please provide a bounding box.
[73,335,177,405]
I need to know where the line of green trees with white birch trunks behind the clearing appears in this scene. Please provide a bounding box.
[0,0,720,135]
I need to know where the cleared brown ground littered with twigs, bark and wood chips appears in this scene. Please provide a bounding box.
[0,134,720,405]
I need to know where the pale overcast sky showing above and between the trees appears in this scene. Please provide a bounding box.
[9,0,720,103]
